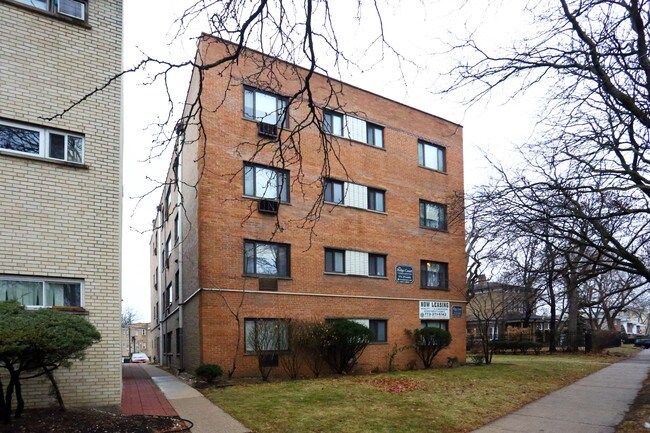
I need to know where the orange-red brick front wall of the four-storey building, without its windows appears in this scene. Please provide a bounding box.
[177,39,466,374]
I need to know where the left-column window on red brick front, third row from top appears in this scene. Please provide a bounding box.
[244,241,290,277]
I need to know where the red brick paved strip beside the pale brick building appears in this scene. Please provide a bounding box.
[122,364,178,416]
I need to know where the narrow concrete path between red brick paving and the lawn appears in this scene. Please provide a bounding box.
[135,365,250,433]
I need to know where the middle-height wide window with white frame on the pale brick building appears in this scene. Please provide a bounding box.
[0,121,84,164]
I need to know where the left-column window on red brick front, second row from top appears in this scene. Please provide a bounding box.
[244,164,289,203]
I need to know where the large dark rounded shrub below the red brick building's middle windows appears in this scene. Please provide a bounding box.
[324,319,372,374]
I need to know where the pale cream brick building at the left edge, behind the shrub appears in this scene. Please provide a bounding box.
[0,0,122,407]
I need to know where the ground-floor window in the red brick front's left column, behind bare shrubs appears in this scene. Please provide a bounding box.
[244,319,289,353]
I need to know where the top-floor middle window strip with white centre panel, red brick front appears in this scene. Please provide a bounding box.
[323,109,384,147]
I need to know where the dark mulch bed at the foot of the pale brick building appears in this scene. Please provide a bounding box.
[0,409,191,433]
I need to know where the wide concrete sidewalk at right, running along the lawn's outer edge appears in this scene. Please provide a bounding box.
[473,350,650,433]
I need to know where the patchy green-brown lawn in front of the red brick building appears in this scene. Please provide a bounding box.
[206,355,636,433]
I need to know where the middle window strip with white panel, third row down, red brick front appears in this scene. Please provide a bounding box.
[325,248,386,278]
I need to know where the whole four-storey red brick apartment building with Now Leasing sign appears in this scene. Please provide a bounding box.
[151,35,466,375]
